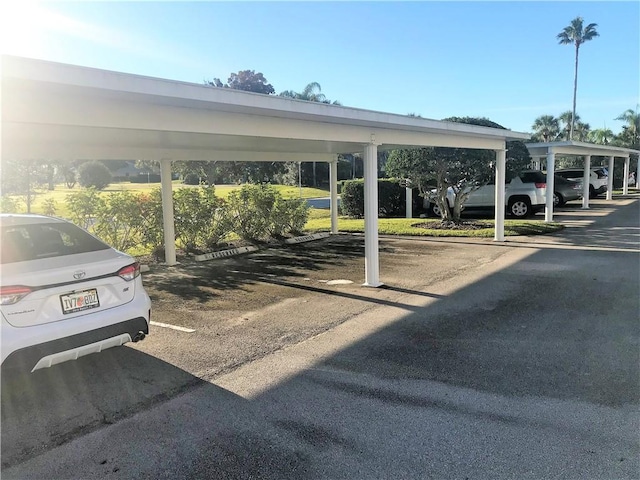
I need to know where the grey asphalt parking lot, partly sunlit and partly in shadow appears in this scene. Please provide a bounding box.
[2,197,640,479]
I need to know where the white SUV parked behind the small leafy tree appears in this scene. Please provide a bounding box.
[425,170,547,218]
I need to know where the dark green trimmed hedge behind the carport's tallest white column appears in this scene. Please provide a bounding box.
[340,179,420,218]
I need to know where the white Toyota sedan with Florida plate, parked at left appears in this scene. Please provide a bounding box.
[0,214,151,372]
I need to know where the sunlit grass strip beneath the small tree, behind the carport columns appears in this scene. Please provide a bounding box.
[305,208,564,238]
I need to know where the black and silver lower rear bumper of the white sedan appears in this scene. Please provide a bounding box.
[2,317,149,372]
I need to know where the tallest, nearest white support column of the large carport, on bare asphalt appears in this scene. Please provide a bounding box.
[363,143,382,287]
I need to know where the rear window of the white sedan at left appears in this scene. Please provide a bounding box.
[0,223,110,264]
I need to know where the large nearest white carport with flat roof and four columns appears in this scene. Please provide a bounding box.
[1,55,529,287]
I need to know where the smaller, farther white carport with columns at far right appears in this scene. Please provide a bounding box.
[526,141,640,222]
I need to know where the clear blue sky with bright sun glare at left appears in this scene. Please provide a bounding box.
[0,0,640,133]
